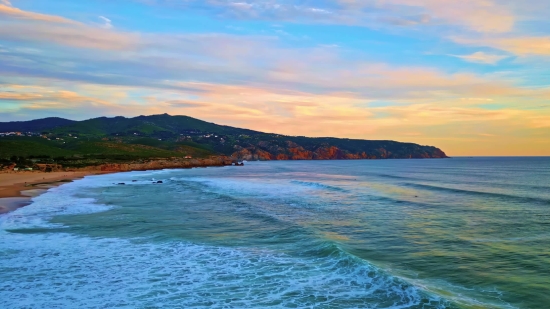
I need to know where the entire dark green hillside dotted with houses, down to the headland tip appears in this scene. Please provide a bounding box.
[0,114,447,164]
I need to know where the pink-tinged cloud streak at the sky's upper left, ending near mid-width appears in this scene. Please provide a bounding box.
[0,5,276,53]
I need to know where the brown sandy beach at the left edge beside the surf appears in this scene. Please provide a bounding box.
[0,171,95,214]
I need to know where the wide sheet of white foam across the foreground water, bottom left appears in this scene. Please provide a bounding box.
[0,233,445,309]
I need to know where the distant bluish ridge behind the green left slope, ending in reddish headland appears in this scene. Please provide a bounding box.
[0,114,447,160]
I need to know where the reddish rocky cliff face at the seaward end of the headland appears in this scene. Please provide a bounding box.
[232,141,447,161]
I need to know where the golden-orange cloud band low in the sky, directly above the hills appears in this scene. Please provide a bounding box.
[4,81,550,155]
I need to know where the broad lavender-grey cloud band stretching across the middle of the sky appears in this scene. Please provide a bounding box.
[0,25,538,103]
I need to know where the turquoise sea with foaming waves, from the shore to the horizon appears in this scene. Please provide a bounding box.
[0,158,550,309]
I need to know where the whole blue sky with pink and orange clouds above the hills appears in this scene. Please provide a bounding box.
[0,0,550,156]
